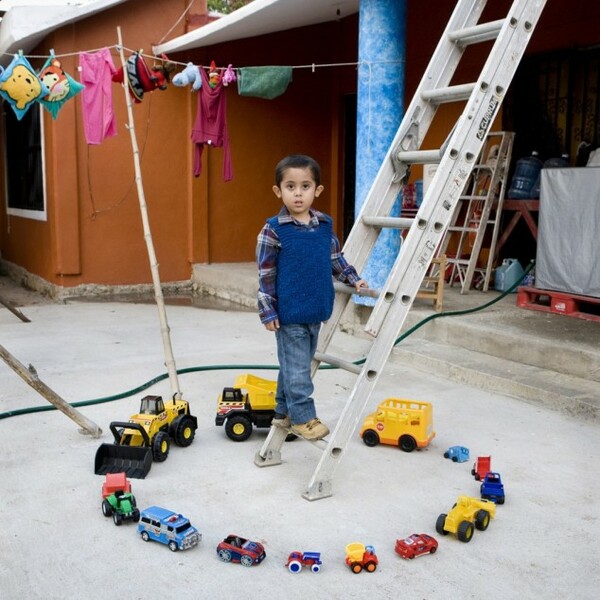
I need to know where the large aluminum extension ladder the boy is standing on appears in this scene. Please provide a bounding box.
[254,0,545,500]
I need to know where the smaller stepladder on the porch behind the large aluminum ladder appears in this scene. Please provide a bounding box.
[438,131,515,294]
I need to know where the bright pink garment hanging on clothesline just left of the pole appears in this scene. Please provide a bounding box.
[79,48,117,144]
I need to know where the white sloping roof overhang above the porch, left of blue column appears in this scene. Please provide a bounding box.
[153,0,360,55]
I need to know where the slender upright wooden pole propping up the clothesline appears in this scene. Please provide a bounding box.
[117,27,181,398]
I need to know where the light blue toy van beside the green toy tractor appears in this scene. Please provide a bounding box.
[138,506,202,552]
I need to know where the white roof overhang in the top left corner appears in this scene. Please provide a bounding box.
[0,0,127,65]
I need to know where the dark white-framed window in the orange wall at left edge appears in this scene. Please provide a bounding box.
[4,104,46,221]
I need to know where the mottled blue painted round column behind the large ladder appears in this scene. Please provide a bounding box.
[354,0,406,305]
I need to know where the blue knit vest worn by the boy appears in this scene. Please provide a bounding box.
[268,215,335,325]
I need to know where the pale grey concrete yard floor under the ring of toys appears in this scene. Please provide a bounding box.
[0,294,600,600]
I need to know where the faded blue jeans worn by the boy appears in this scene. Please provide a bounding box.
[275,323,321,425]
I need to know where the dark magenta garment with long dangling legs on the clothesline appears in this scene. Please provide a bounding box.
[192,69,233,181]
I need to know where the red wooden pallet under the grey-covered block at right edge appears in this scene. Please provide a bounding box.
[517,286,600,323]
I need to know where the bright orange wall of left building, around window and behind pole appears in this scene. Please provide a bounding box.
[1,0,193,287]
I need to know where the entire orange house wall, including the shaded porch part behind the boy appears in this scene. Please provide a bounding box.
[0,0,600,287]
